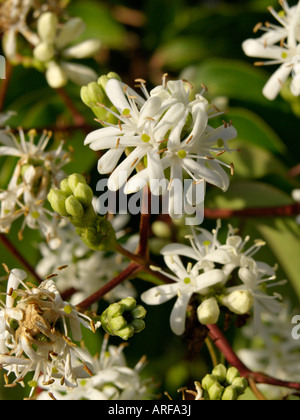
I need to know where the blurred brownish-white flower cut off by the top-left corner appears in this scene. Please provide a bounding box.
[0,0,38,60]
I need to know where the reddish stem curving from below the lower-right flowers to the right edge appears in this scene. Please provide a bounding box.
[207,325,300,391]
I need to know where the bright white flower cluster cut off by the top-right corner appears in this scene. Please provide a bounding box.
[243,1,300,100]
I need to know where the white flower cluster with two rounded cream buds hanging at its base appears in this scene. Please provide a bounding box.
[141,223,281,335]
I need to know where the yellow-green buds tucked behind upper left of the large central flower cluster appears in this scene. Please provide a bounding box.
[81,72,121,124]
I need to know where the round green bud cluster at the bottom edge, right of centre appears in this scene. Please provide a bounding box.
[201,364,248,401]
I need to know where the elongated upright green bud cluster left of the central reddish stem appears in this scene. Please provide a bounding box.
[48,174,117,251]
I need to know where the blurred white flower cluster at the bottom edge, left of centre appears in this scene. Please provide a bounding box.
[38,336,149,401]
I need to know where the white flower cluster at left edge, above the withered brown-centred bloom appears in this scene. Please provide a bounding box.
[0,129,69,246]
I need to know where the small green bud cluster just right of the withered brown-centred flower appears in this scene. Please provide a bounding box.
[100,297,146,340]
